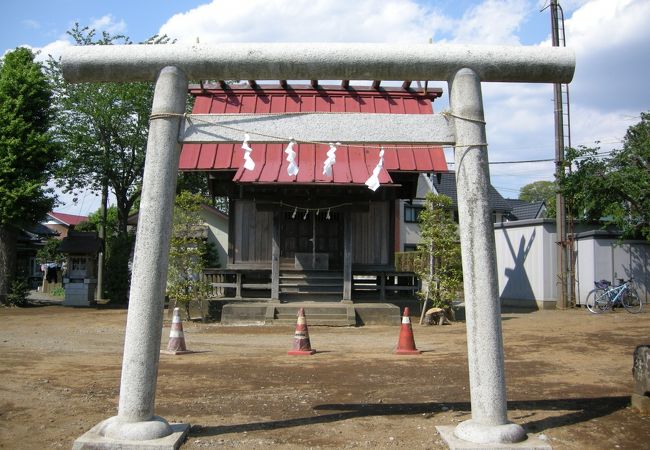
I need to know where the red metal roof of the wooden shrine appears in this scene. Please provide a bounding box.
[180,87,447,184]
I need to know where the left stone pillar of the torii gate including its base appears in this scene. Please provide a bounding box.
[73,67,189,449]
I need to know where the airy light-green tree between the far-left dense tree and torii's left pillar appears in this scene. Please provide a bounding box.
[47,24,168,235]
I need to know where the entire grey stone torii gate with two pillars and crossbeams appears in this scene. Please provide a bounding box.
[62,44,575,448]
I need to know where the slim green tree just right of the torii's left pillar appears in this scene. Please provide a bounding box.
[167,191,209,319]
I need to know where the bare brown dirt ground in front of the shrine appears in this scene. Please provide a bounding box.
[0,300,650,449]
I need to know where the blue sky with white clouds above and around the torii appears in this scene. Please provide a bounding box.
[0,0,650,214]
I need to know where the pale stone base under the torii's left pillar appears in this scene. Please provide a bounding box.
[72,416,190,450]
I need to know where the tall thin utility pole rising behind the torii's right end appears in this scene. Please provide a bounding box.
[550,0,573,309]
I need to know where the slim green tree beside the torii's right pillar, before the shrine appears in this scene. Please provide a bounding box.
[416,192,463,311]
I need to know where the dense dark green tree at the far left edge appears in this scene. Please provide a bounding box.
[0,48,60,301]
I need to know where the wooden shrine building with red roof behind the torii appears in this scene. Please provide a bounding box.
[180,82,447,301]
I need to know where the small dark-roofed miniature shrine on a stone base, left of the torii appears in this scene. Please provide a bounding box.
[60,231,101,306]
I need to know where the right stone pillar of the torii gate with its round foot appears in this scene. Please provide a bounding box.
[449,69,526,444]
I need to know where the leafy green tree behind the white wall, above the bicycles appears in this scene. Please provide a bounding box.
[562,112,650,240]
